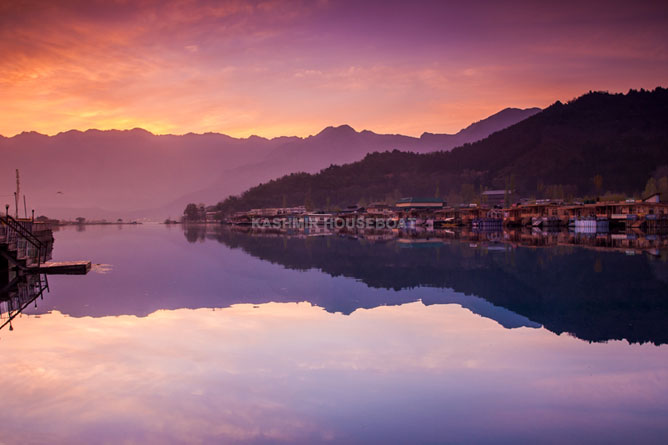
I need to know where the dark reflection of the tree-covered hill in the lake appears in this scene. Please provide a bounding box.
[186,227,668,344]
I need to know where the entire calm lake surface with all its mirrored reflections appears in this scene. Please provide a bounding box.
[0,225,668,443]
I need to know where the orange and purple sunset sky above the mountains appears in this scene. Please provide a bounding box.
[0,0,668,137]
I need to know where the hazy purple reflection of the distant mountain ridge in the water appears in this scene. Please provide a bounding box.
[27,226,540,328]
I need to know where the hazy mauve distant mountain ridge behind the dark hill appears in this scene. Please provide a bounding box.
[0,109,537,219]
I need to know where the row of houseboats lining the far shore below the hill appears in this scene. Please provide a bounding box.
[224,194,668,233]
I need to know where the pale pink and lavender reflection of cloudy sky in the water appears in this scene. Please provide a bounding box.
[0,303,668,443]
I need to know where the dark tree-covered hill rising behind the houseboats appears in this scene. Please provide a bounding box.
[213,88,668,213]
